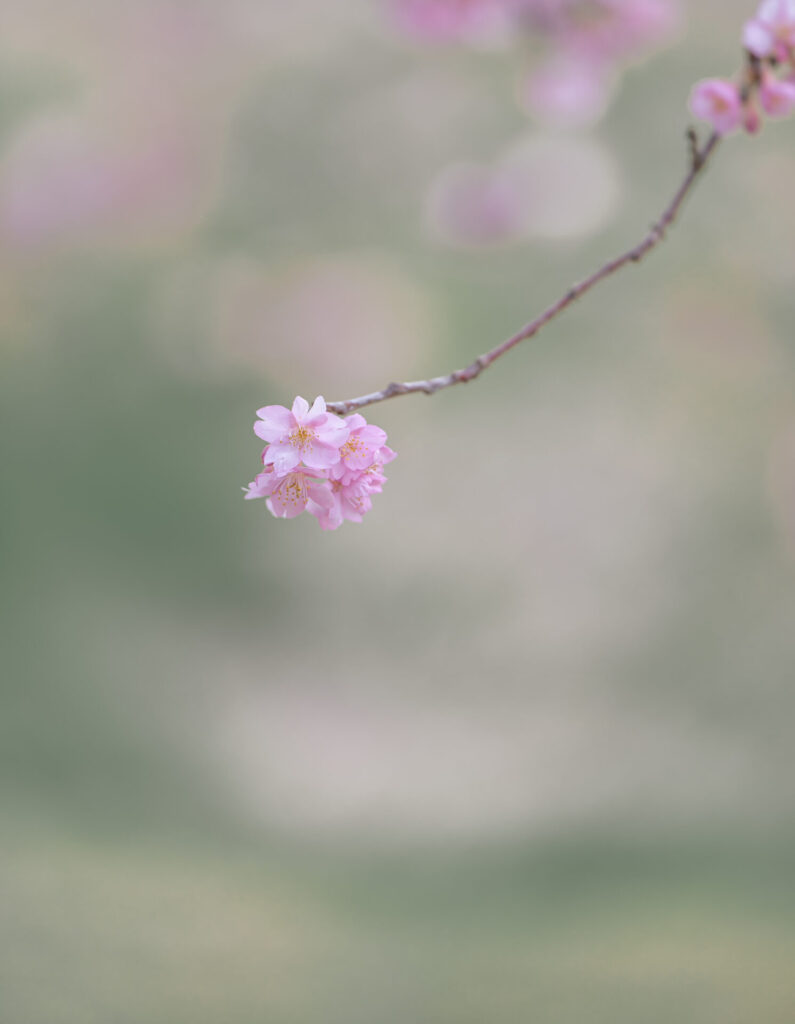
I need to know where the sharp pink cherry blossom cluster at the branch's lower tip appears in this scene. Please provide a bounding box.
[244,396,395,529]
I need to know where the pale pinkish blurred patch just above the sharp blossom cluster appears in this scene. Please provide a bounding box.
[154,250,435,394]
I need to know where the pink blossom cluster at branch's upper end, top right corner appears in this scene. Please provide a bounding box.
[691,0,795,135]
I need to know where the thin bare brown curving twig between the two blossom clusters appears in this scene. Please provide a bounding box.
[327,128,720,416]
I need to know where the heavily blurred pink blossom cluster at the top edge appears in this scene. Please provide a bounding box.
[391,0,677,122]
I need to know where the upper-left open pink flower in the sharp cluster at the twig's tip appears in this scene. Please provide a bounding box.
[254,396,349,475]
